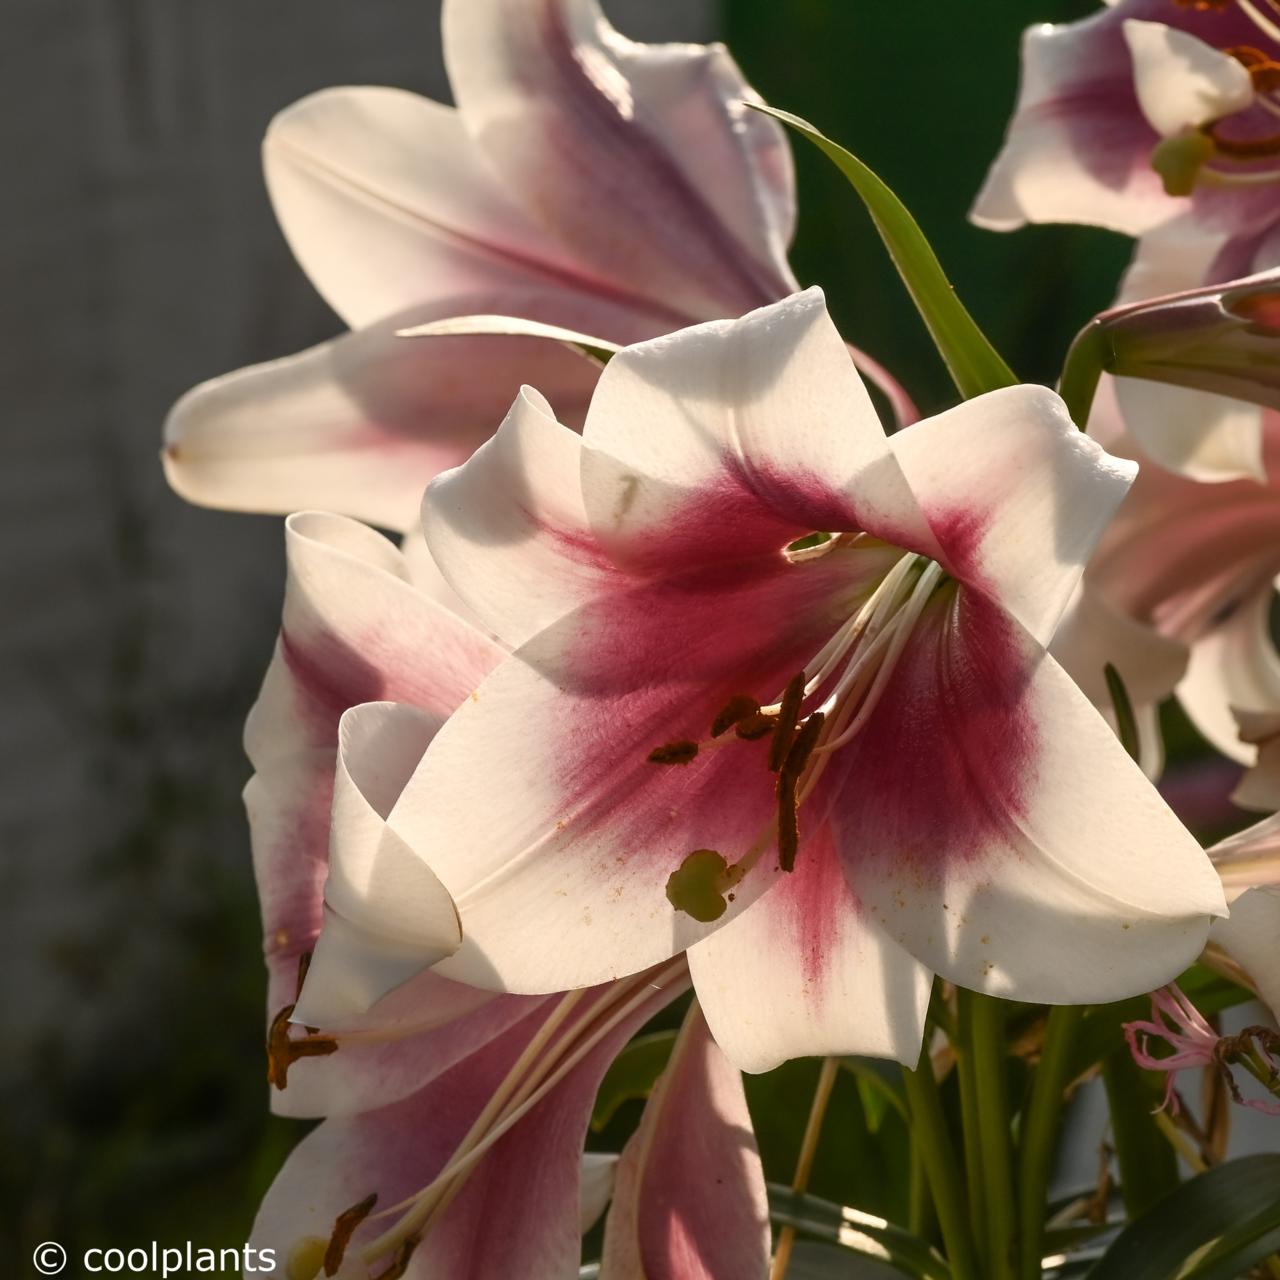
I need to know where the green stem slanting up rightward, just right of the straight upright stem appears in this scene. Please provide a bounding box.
[1018,1005,1084,1280]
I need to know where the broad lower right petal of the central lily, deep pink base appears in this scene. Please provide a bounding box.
[824,589,1224,1004]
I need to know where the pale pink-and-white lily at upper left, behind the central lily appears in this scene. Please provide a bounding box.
[164,0,914,530]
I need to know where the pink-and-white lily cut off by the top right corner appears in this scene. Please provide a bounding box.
[972,0,1280,283]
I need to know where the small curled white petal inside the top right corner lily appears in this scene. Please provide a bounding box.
[1124,18,1253,138]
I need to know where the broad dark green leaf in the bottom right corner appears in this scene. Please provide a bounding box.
[1088,1155,1280,1280]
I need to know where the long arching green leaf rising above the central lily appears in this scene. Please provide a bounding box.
[750,102,1018,399]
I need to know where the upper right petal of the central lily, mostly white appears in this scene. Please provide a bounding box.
[892,387,1137,643]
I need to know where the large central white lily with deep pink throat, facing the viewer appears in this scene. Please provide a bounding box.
[343,289,1224,1070]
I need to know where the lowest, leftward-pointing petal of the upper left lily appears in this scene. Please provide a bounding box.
[164,293,650,529]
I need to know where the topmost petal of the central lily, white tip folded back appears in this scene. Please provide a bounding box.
[582,289,936,571]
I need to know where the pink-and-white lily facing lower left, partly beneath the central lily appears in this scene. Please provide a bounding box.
[246,513,769,1280]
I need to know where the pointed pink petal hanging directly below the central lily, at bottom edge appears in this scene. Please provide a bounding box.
[600,1006,769,1280]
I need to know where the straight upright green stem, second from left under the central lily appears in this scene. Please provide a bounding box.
[965,993,1016,1280]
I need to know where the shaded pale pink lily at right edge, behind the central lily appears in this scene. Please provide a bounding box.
[1053,373,1280,809]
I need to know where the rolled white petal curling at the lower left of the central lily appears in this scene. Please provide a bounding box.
[293,703,462,1030]
